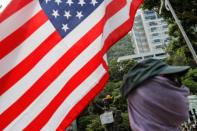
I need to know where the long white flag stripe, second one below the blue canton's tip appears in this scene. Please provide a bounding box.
[5,36,101,131]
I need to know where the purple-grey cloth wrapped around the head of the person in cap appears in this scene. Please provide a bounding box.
[127,76,189,131]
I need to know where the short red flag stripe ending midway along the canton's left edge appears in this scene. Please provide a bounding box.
[0,11,48,59]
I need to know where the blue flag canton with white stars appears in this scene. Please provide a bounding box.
[39,0,104,37]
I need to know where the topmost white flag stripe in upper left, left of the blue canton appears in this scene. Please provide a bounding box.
[0,0,41,41]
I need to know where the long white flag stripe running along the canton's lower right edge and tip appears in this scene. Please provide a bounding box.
[0,0,105,113]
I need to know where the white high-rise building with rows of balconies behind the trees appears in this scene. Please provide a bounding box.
[118,10,169,61]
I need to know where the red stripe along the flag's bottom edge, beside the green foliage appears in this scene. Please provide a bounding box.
[56,73,109,131]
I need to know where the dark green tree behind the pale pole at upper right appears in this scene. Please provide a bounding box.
[143,0,197,66]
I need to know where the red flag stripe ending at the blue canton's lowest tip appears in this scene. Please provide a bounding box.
[0,32,62,95]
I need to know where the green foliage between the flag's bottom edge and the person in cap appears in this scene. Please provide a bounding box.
[78,59,135,131]
